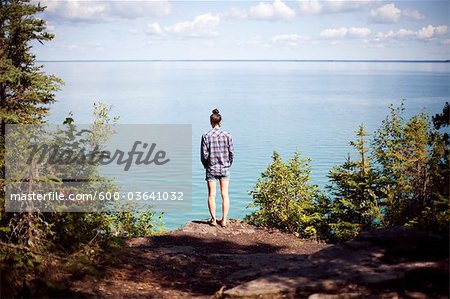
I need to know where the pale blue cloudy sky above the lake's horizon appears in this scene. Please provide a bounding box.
[33,0,450,60]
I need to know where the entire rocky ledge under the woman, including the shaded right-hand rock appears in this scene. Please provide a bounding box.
[71,220,449,298]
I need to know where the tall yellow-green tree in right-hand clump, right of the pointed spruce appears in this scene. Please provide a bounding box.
[373,104,442,226]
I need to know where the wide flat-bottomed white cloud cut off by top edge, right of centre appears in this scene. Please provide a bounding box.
[299,0,378,15]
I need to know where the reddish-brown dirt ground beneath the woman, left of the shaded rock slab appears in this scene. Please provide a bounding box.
[72,220,329,298]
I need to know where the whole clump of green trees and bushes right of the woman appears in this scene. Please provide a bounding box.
[248,103,450,242]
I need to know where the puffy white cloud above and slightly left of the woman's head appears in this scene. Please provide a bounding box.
[165,13,220,37]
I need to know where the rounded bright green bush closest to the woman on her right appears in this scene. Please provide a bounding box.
[247,152,321,237]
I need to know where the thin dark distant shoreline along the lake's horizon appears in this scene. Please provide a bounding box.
[37,59,450,63]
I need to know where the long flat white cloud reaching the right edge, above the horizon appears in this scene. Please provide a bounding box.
[374,25,448,42]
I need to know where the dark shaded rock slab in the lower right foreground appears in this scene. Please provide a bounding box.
[224,227,448,298]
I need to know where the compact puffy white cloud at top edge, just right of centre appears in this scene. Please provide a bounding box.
[247,0,295,21]
